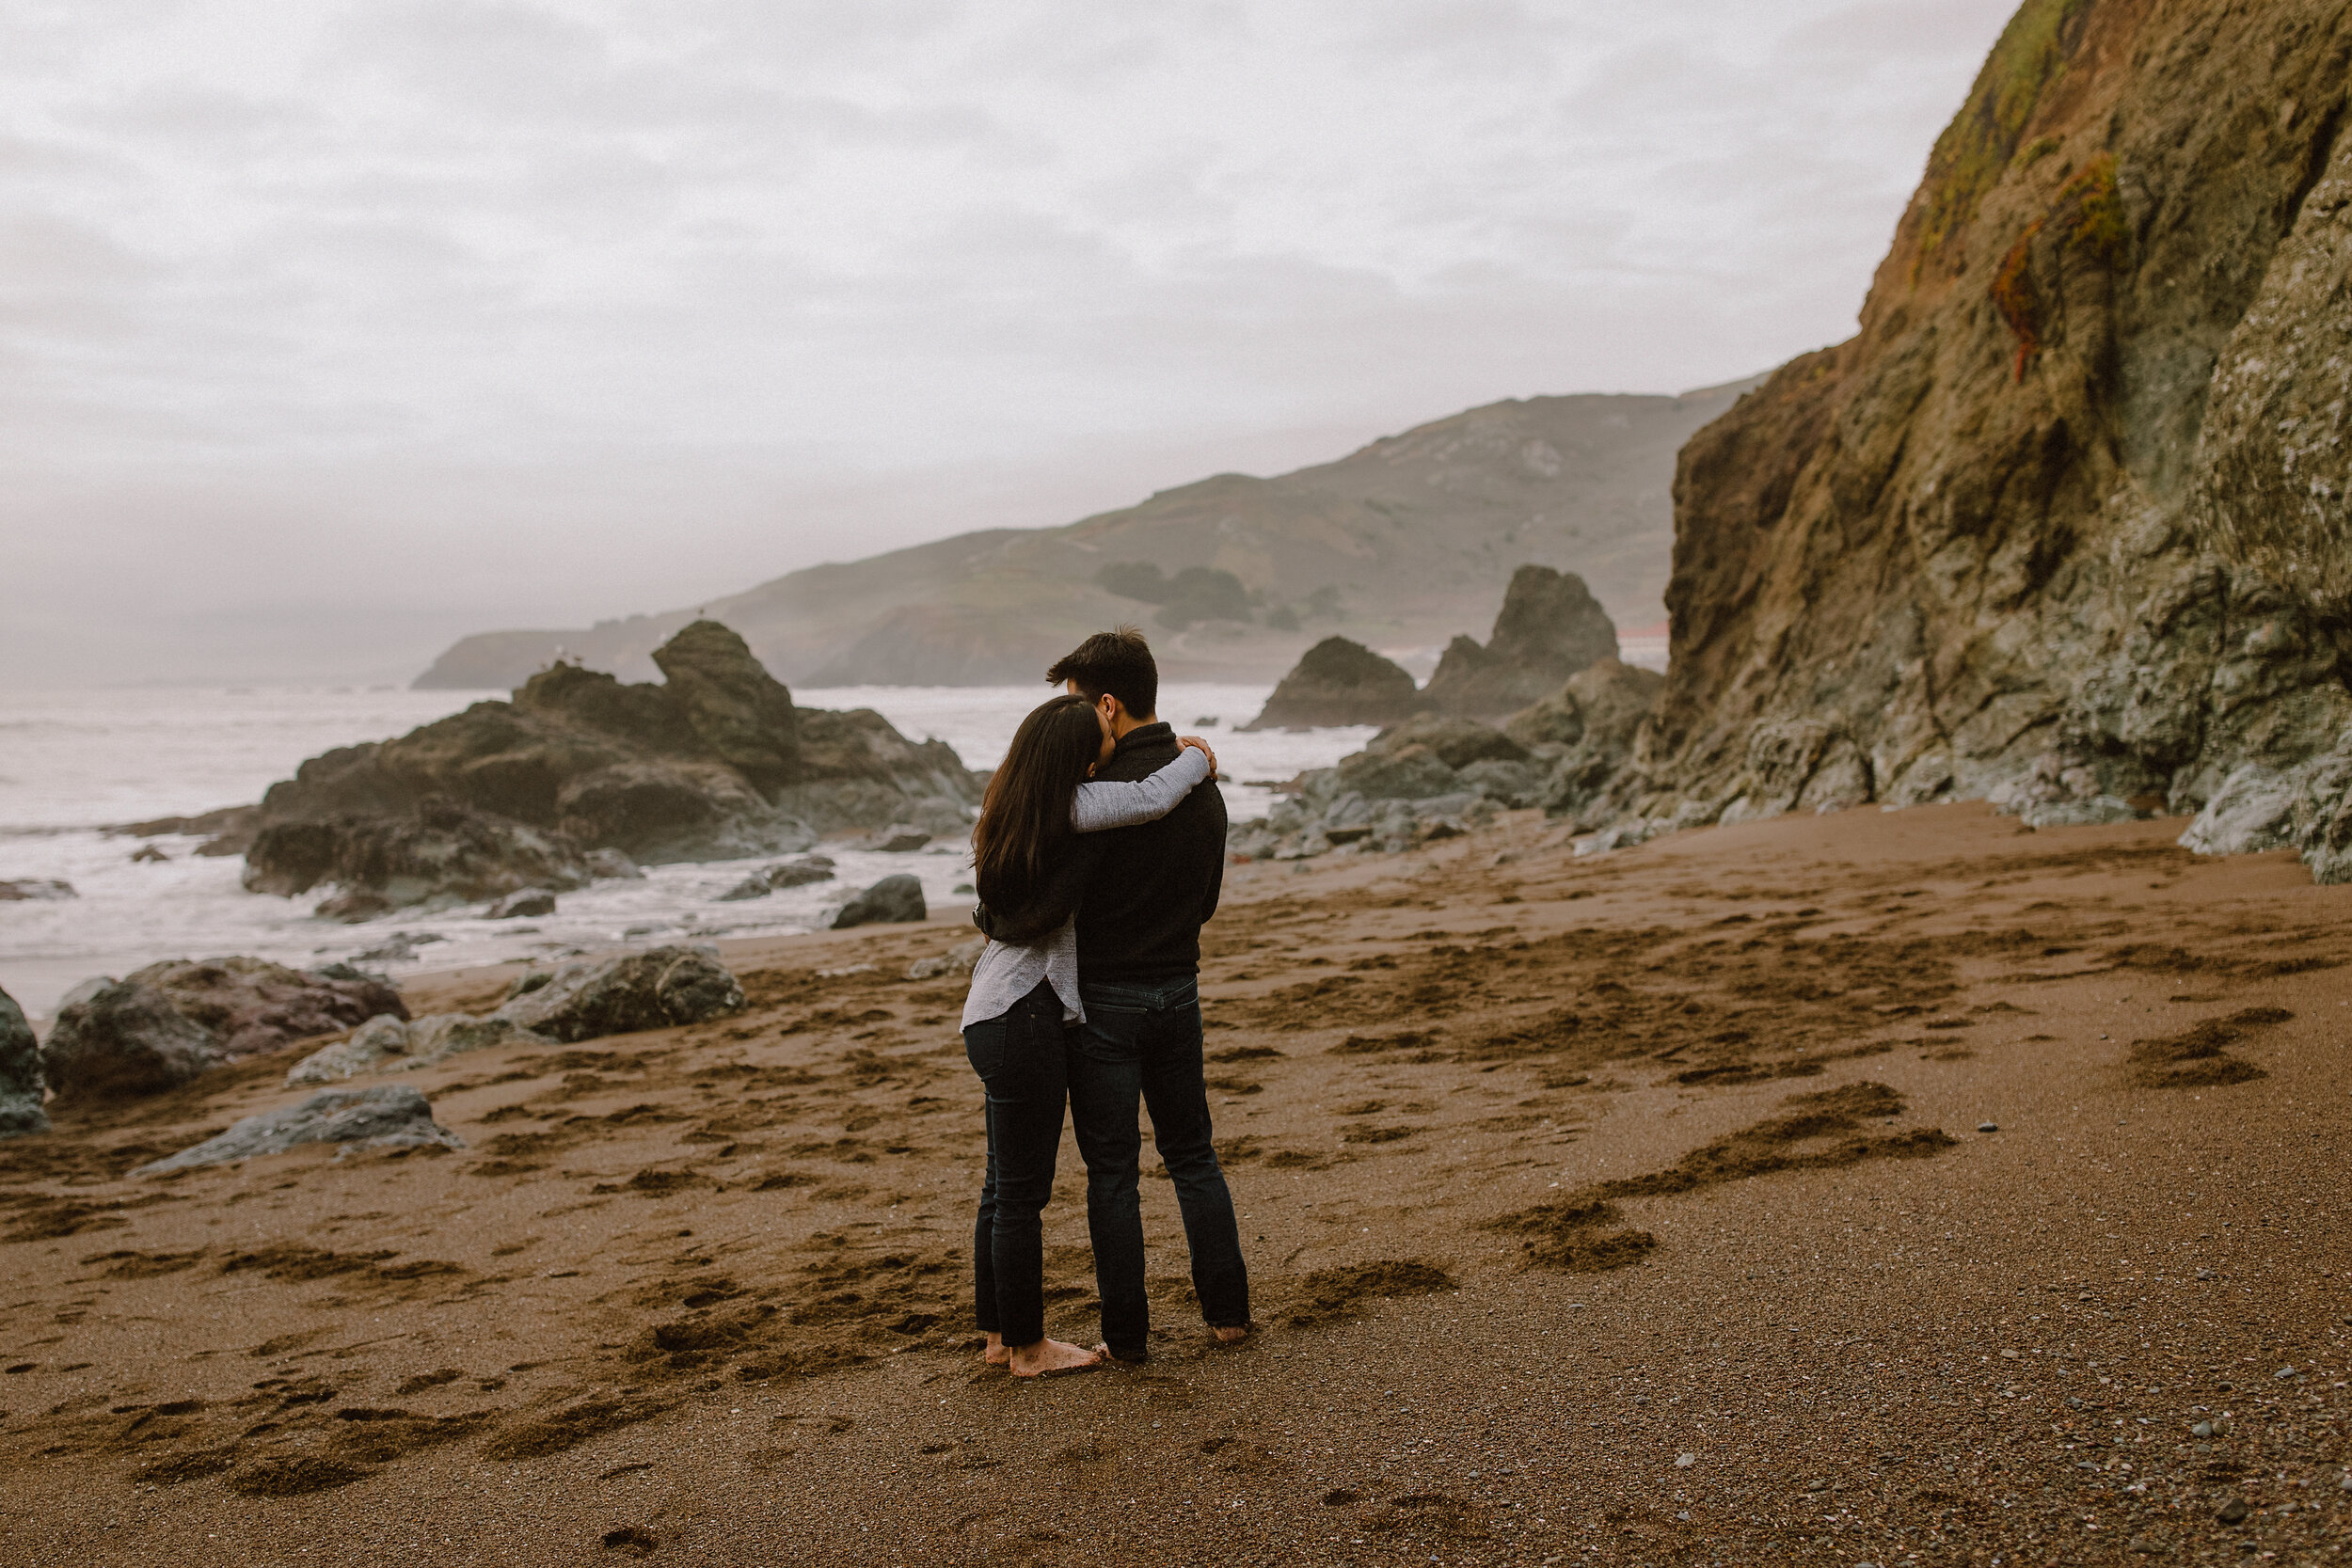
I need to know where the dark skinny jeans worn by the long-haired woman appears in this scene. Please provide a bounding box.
[964,980,1071,1345]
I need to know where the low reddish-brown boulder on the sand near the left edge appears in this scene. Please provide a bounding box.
[42,957,409,1098]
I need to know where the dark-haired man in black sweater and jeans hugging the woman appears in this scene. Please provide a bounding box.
[1047,626,1249,1361]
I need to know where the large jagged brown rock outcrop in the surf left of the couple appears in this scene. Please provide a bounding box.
[245,621,978,908]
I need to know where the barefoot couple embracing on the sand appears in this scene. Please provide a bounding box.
[964,627,1249,1378]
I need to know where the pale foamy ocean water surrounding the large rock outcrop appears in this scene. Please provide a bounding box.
[0,684,1374,1018]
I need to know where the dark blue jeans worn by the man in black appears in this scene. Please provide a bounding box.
[1071,975,1249,1361]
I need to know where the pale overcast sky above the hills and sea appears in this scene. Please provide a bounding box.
[0,0,2011,687]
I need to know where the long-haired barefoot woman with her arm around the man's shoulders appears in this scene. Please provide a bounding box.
[964,696,1216,1378]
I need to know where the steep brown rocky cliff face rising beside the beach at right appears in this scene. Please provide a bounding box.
[1612,0,2352,823]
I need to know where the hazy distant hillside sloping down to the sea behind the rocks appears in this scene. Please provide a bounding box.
[417,383,1745,689]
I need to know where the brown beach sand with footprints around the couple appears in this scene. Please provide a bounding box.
[0,806,2352,1566]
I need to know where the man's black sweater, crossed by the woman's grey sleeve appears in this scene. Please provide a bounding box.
[1077,724,1226,983]
